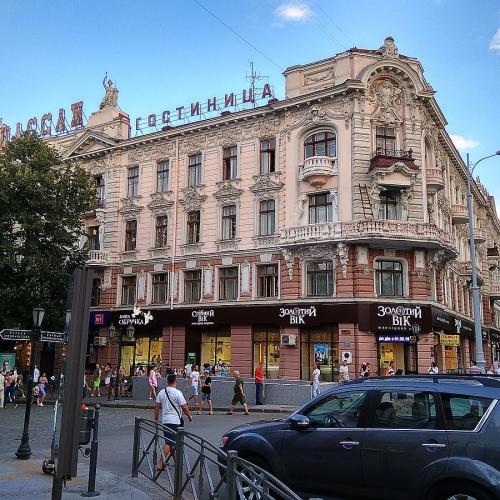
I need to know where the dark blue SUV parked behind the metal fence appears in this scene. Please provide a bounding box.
[221,375,500,500]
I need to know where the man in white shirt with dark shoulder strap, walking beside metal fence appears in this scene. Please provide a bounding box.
[154,373,193,470]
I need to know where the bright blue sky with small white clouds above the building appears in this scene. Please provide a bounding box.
[0,0,500,195]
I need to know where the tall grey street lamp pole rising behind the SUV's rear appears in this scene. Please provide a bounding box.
[467,151,500,372]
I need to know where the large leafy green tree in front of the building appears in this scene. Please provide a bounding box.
[0,133,97,328]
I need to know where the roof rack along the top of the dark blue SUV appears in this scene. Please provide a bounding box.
[347,373,500,388]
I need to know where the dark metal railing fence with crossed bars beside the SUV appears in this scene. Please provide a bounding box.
[132,418,300,500]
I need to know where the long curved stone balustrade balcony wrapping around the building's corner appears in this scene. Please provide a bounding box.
[281,219,456,254]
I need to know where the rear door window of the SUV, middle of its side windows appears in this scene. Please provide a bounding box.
[373,391,438,429]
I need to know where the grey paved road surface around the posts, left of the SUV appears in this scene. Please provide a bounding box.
[0,405,283,499]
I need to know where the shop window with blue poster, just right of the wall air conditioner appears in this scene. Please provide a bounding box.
[300,327,340,382]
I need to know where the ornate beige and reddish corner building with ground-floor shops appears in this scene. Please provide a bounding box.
[28,37,500,380]
